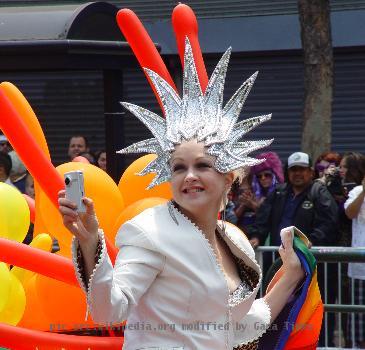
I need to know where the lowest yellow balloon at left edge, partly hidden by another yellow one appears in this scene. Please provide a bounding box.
[0,274,25,326]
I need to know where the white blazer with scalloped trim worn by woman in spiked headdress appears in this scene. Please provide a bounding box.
[73,204,271,350]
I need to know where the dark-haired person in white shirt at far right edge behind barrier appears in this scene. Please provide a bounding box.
[340,152,365,349]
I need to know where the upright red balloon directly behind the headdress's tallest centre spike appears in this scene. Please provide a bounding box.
[172,4,208,93]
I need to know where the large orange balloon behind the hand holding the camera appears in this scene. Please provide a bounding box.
[36,162,124,249]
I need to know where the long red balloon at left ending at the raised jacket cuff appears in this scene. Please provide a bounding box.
[0,238,79,286]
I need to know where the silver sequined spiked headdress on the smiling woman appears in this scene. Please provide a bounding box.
[117,38,273,189]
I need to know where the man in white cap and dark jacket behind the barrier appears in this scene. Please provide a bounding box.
[247,152,338,345]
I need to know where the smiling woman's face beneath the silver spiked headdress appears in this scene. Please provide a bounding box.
[170,140,233,215]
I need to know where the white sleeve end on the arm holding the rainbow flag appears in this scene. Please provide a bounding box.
[233,298,271,347]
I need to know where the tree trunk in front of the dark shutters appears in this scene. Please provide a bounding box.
[298,0,333,160]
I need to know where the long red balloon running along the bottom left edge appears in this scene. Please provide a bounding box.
[0,322,124,350]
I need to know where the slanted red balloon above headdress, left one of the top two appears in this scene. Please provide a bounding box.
[117,9,177,112]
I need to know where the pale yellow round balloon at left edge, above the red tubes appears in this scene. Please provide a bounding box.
[0,182,30,242]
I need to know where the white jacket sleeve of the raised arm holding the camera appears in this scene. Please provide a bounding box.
[72,223,165,325]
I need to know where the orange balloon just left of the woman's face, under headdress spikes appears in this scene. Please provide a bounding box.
[118,154,172,206]
